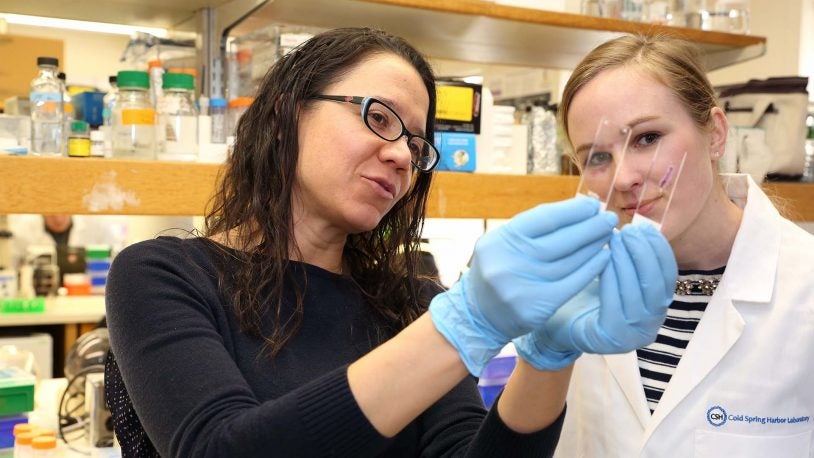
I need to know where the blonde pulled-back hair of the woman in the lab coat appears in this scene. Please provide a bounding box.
[558,35,718,148]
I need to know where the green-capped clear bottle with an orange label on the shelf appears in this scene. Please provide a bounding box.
[111,70,156,159]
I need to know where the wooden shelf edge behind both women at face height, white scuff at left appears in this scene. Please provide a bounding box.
[0,156,814,221]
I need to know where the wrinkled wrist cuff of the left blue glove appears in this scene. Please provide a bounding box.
[430,292,506,377]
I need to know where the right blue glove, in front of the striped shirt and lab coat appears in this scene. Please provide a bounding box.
[514,224,678,370]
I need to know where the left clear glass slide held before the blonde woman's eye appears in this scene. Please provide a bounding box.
[576,119,631,210]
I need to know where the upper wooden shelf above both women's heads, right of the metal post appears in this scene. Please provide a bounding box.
[231,0,766,70]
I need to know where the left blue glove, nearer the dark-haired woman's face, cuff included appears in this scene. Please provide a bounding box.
[430,197,618,376]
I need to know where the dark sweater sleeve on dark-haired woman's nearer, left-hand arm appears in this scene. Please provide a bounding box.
[106,239,388,457]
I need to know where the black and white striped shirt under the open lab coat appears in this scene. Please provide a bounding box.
[636,267,724,414]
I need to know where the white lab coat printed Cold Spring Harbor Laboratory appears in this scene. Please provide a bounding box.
[556,175,814,458]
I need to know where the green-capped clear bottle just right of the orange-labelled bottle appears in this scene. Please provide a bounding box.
[158,73,198,161]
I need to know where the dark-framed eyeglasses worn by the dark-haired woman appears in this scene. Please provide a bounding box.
[312,95,439,172]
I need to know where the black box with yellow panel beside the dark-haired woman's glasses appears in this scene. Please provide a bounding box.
[435,81,483,134]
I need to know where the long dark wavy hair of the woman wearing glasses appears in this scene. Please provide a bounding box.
[204,28,436,356]
